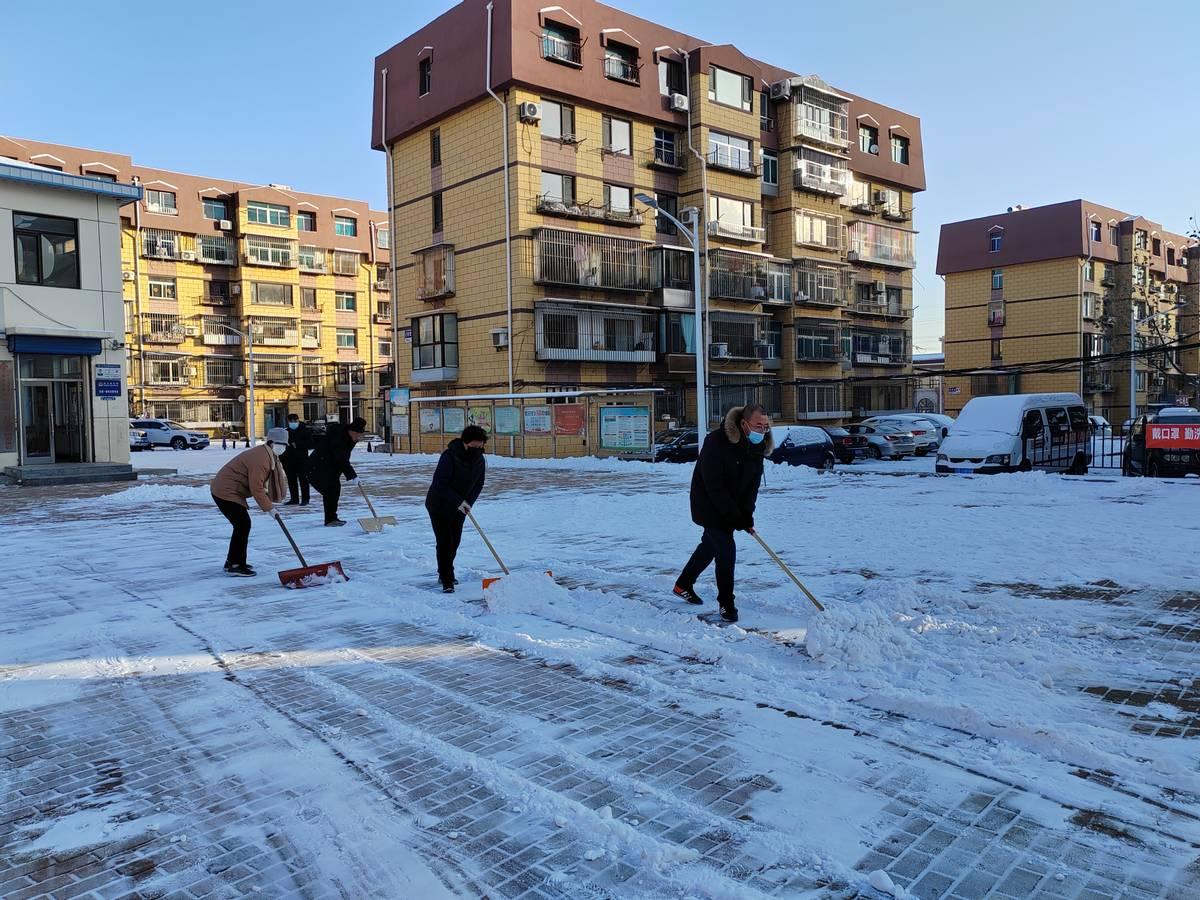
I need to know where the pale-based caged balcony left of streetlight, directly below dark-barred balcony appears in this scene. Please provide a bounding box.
[534,300,658,362]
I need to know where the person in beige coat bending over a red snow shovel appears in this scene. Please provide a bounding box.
[210,428,288,577]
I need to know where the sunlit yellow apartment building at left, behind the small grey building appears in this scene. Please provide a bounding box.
[0,137,392,436]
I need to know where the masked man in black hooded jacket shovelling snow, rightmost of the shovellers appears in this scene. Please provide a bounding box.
[674,403,773,622]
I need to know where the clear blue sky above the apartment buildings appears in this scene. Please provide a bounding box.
[0,0,1200,352]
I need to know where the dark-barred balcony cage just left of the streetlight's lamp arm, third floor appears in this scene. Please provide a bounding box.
[533,228,652,292]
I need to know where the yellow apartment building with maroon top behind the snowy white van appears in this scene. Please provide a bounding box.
[937,200,1198,426]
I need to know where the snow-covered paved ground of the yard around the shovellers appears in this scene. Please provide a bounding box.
[0,449,1200,898]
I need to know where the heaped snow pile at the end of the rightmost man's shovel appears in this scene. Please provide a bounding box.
[804,599,917,668]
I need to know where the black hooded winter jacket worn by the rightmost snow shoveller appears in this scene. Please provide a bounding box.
[691,407,774,532]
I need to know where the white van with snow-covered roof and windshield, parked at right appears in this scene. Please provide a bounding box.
[936,394,1092,475]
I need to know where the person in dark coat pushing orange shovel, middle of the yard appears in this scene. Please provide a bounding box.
[425,425,487,594]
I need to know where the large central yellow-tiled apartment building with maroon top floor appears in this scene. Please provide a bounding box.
[372,0,925,446]
